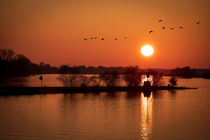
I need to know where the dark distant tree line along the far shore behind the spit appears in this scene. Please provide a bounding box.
[0,49,210,80]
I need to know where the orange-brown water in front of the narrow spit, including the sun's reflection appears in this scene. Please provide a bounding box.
[0,79,210,140]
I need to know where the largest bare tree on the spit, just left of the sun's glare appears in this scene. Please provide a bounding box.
[123,66,142,87]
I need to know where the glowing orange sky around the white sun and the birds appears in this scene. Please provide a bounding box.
[0,0,210,68]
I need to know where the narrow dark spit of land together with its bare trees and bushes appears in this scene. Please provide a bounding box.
[0,67,197,96]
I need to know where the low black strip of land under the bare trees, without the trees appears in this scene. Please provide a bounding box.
[0,86,197,96]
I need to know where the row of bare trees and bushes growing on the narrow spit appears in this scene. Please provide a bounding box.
[58,66,177,87]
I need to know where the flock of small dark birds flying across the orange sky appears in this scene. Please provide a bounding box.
[84,19,200,40]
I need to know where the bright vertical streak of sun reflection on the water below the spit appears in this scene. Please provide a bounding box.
[140,93,153,140]
